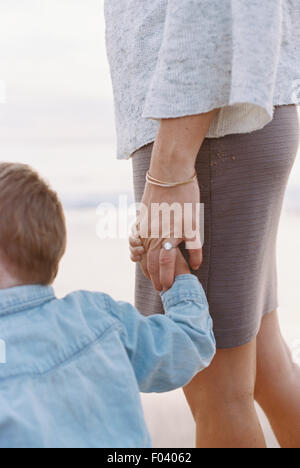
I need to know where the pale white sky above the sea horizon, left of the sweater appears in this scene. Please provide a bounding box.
[0,0,114,141]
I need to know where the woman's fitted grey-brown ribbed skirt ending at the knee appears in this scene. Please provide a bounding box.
[133,106,299,348]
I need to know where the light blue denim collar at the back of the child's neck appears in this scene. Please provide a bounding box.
[0,285,55,316]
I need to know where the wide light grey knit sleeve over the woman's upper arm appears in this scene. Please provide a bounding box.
[143,0,282,134]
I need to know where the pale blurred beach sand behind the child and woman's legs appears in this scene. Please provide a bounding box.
[55,209,300,448]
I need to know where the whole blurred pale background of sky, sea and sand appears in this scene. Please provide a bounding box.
[0,0,300,448]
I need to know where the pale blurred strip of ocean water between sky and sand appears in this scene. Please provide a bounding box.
[1,140,300,215]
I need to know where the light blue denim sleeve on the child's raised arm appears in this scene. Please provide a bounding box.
[104,275,215,393]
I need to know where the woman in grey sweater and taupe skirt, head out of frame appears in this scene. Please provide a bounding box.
[105,0,300,448]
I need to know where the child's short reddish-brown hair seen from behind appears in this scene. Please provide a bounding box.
[0,163,67,285]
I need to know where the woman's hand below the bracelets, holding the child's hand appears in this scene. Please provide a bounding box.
[131,179,202,291]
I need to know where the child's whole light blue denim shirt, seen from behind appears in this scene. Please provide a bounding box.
[0,275,215,448]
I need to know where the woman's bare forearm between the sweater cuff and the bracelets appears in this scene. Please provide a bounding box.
[150,110,218,182]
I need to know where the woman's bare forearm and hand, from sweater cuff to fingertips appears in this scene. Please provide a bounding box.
[130,111,216,291]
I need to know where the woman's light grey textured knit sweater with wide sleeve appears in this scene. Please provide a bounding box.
[105,0,300,159]
